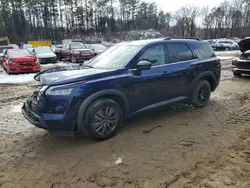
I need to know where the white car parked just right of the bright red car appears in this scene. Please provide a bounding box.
[34,46,57,64]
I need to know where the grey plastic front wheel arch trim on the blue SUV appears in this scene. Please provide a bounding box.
[77,89,129,130]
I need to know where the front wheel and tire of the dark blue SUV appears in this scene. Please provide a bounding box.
[82,99,123,140]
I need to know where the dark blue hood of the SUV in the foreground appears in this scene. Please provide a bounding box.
[40,68,113,85]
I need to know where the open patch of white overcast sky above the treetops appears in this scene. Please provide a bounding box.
[147,0,223,12]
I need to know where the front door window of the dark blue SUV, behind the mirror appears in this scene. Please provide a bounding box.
[139,45,166,66]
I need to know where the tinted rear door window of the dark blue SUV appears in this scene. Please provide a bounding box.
[167,43,195,63]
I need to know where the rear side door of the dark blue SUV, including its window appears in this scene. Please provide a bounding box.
[166,42,199,97]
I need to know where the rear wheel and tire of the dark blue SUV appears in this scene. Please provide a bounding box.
[192,80,211,108]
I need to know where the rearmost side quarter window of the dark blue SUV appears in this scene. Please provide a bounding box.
[188,42,215,59]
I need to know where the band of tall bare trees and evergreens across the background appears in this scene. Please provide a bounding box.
[0,0,250,42]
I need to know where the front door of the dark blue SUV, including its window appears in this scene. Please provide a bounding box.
[129,44,173,112]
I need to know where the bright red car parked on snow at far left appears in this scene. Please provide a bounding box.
[2,49,40,74]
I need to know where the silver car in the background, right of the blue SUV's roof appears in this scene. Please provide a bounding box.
[211,39,239,51]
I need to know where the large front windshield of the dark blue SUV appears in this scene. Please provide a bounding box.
[88,45,142,69]
